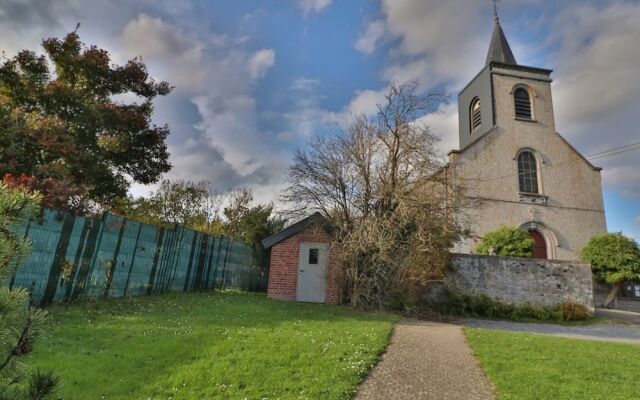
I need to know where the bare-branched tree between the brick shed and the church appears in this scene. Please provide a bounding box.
[284,82,464,308]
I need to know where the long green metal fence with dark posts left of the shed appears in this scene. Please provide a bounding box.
[10,209,266,305]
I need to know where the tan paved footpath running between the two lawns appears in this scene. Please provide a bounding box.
[356,320,495,400]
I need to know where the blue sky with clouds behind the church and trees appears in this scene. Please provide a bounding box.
[0,0,640,239]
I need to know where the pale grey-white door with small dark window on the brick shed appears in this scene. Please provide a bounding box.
[296,243,328,303]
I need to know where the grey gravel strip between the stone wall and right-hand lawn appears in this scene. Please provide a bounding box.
[459,319,640,344]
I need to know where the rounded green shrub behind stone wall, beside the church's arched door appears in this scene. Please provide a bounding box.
[476,226,533,257]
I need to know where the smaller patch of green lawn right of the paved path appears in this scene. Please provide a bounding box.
[465,328,640,400]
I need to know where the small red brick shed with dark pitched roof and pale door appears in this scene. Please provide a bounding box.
[262,213,340,304]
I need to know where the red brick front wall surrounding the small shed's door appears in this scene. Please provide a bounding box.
[267,226,340,304]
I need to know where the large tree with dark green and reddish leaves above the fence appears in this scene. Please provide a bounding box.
[0,31,171,212]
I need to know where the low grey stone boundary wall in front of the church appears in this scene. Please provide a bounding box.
[446,254,594,311]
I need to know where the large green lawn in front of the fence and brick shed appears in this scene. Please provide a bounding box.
[32,292,397,400]
